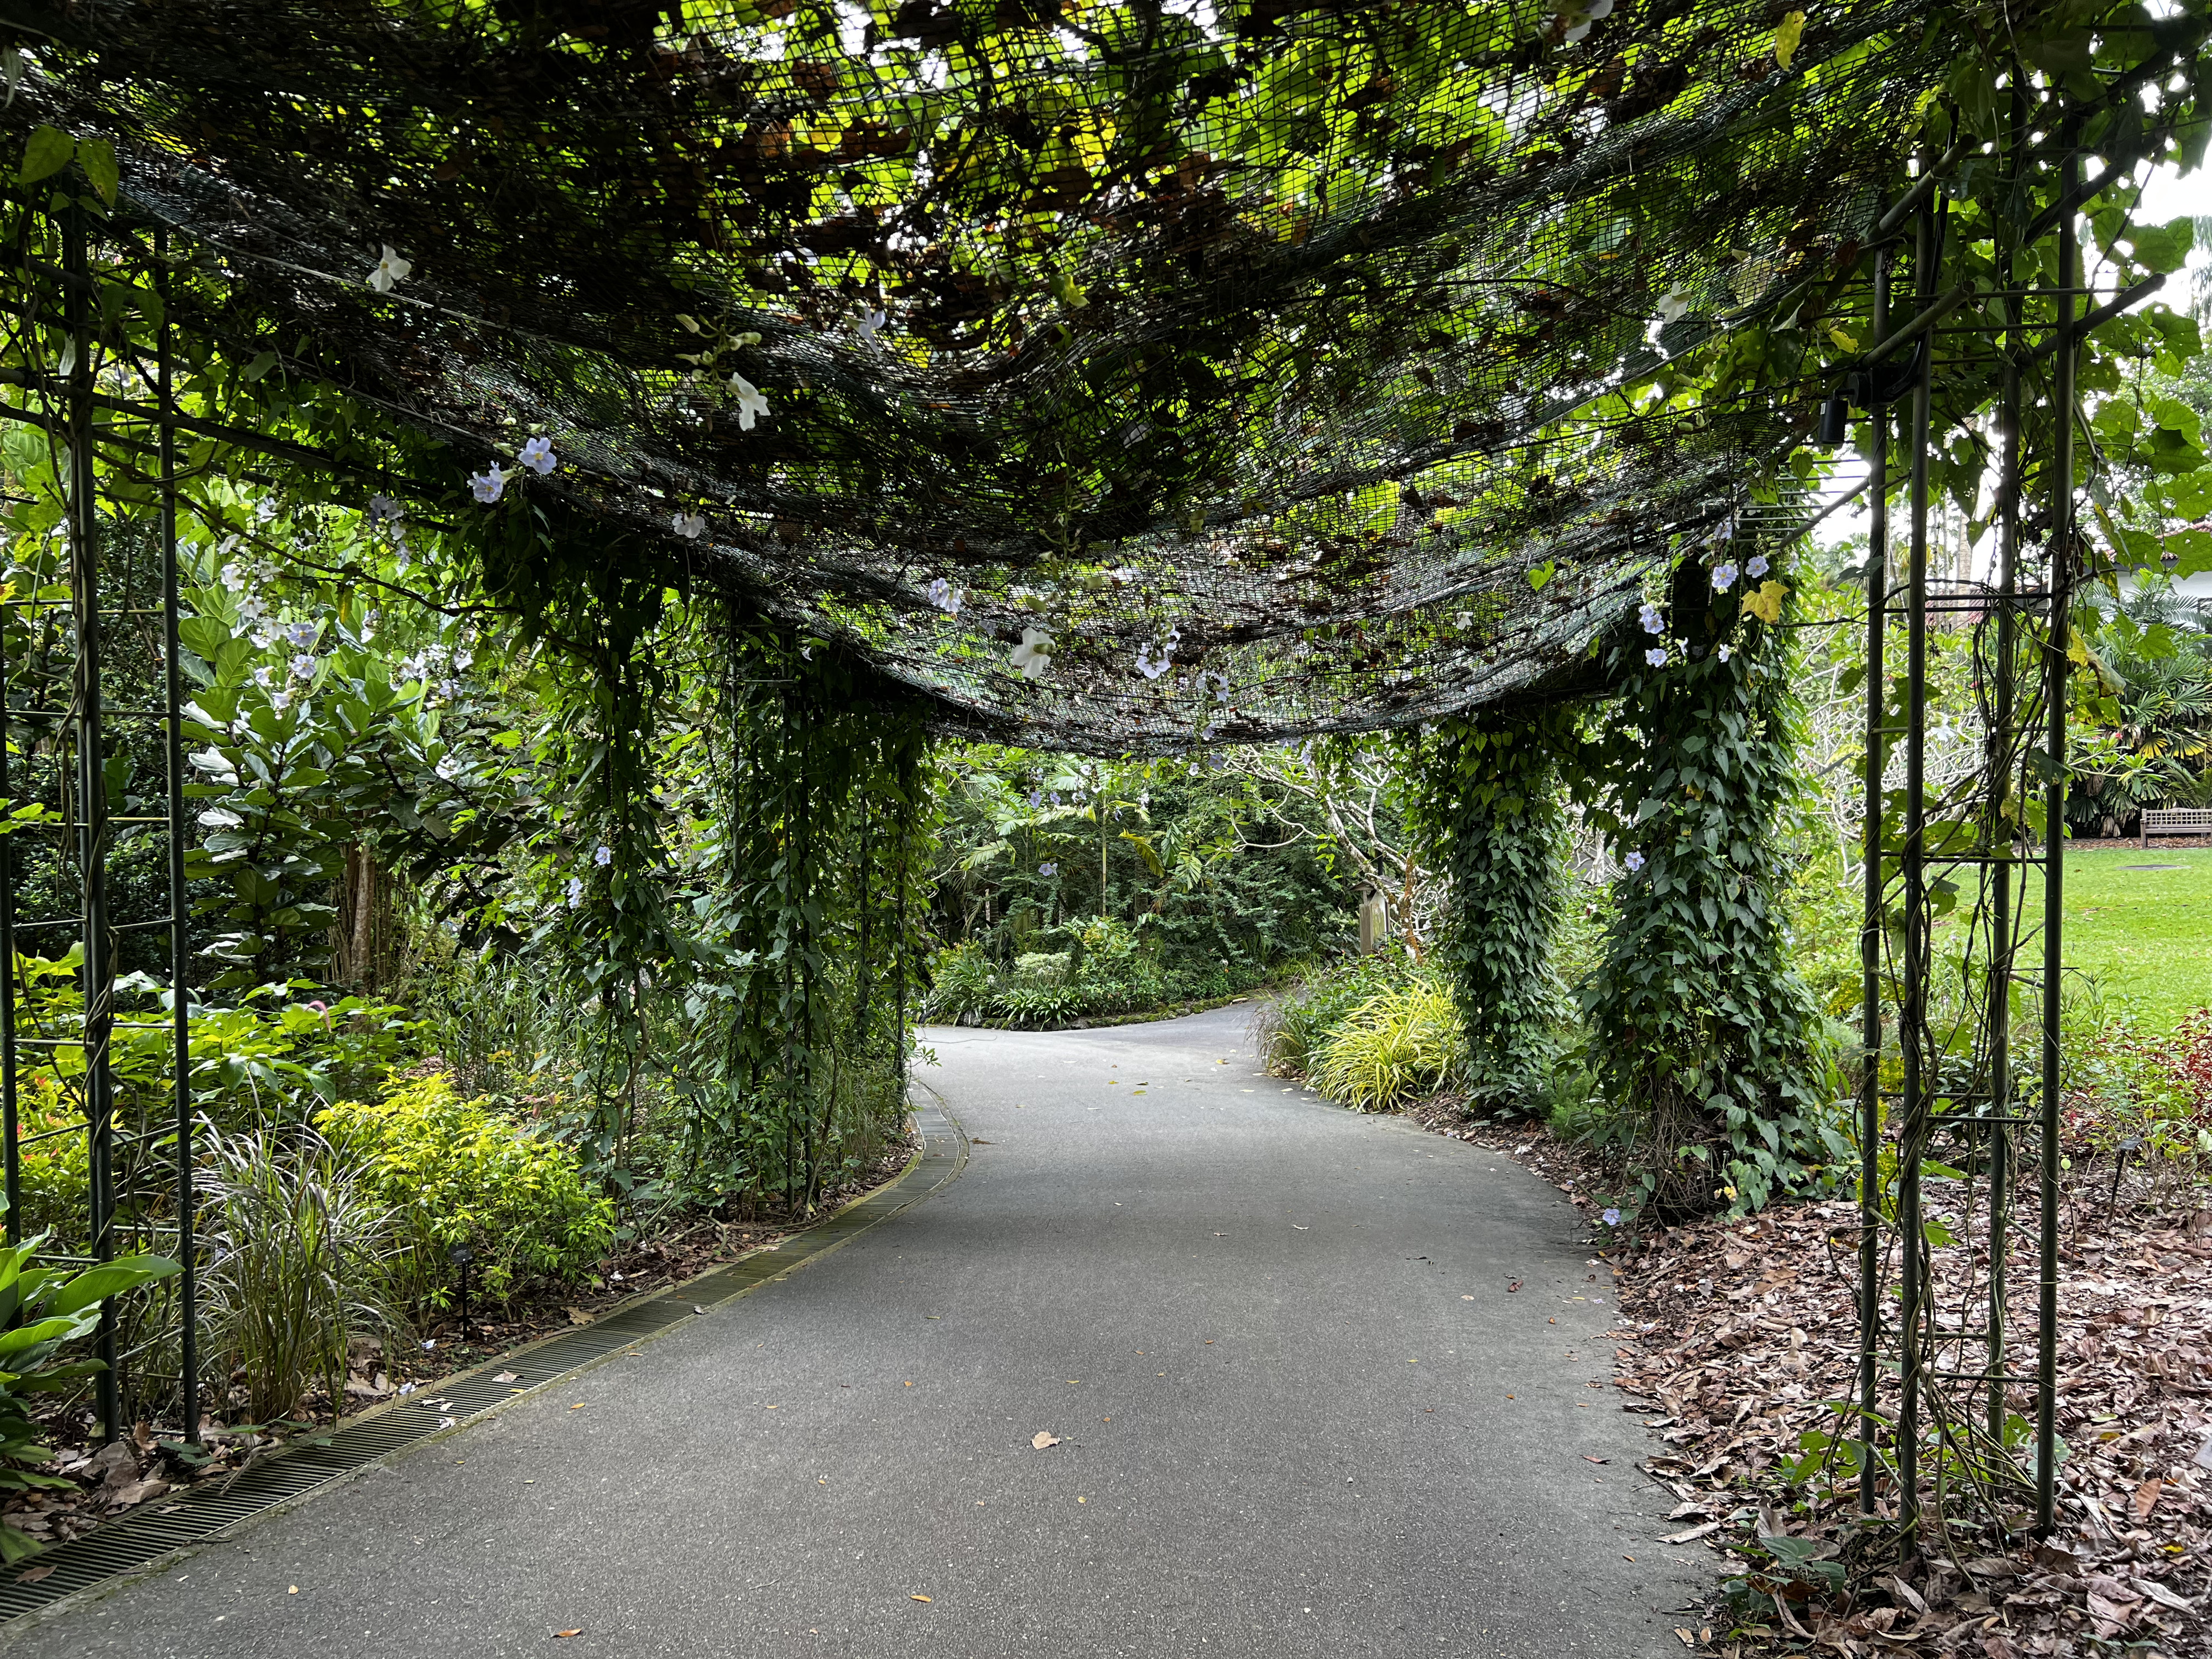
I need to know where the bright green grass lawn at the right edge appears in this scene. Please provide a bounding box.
[2026,841,2212,1031]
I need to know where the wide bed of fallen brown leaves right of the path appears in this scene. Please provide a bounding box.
[1409,1097,2212,1659]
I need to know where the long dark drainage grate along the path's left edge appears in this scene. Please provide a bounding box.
[0,1104,967,1621]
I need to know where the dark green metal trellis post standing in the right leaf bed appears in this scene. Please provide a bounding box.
[1838,146,2088,1557]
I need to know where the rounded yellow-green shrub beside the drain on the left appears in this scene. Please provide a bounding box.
[316,1073,615,1307]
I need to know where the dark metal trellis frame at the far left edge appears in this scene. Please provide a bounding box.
[0,204,201,1442]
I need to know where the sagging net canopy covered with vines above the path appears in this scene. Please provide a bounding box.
[0,0,1958,750]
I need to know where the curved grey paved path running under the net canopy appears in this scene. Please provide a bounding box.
[7,1009,1705,1659]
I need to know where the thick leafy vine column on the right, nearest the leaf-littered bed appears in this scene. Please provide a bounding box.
[1582,540,1849,1217]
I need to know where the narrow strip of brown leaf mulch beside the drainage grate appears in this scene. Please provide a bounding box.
[0,1137,920,1582]
